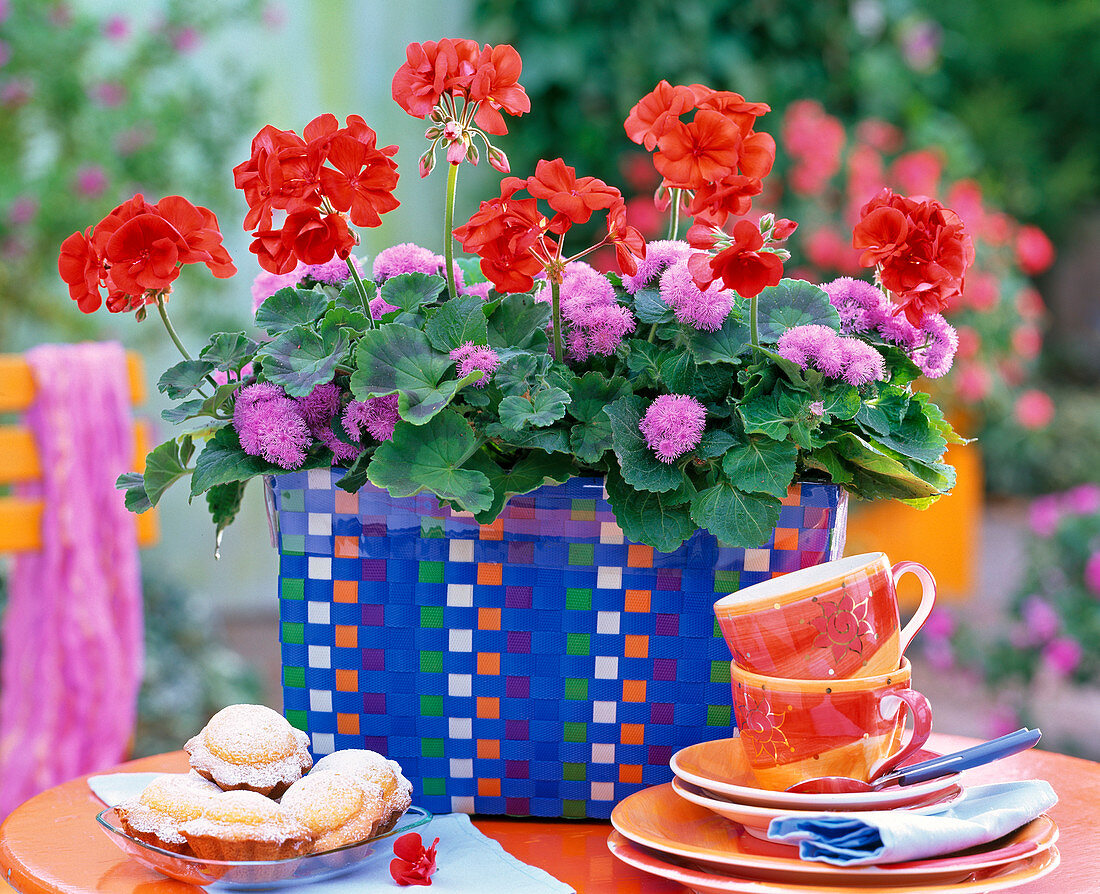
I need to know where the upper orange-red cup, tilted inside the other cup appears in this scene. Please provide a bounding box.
[714,552,936,680]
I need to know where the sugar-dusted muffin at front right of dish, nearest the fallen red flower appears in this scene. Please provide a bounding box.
[281,770,391,851]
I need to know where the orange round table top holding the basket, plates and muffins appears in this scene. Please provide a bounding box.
[0,735,1100,894]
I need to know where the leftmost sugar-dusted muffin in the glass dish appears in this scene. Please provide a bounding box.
[114,772,222,854]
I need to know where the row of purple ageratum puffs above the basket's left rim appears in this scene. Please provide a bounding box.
[233,382,399,468]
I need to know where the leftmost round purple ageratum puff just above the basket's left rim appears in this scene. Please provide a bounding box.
[233,382,312,468]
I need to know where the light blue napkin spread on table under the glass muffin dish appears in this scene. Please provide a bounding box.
[88,773,574,894]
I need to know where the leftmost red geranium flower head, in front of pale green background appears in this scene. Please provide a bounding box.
[57,194,237,313]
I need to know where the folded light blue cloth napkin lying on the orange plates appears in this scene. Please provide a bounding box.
[768,780,1058,867]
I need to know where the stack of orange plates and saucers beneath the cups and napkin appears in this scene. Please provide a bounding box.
[607,738,1059,894]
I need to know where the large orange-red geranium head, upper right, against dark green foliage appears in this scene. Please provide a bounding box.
[624,80,776,227]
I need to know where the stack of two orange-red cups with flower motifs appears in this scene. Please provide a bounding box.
[714,553,936,791]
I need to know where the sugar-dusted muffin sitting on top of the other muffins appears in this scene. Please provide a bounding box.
[184,705,314,797]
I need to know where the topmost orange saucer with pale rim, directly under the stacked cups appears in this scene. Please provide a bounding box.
[669,736,958,810]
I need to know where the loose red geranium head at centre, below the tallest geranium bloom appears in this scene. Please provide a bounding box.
[454,158,646,293]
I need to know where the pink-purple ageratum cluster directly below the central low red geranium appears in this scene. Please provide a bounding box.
[535,261,637,361]
